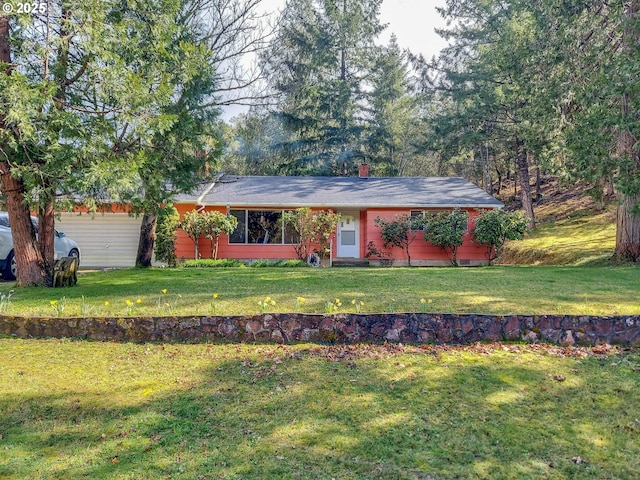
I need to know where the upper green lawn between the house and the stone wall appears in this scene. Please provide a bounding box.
[0,266,640,316]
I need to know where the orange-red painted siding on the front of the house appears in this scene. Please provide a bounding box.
[176,204,496,266]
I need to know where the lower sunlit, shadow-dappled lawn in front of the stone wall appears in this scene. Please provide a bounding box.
[0,338,640,480]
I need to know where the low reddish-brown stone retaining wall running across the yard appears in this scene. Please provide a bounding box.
[0,313,640,345]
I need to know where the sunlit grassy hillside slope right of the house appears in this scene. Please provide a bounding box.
[497,177,616,265]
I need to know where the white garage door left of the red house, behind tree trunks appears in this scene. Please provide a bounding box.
[56,213,142,268]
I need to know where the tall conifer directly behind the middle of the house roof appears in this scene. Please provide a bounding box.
[263,0,383,174]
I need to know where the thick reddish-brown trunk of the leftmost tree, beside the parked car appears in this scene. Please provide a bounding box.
[0,13,46,287]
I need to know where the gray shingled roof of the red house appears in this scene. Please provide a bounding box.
[176,175,502,209]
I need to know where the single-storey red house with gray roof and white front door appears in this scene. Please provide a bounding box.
[175,175,503,266]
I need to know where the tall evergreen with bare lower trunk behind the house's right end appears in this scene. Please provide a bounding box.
[436,0,537,226]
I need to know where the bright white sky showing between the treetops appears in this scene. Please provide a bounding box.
[223,0,446,120]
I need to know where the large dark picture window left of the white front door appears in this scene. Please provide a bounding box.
[229,210,298,245]
